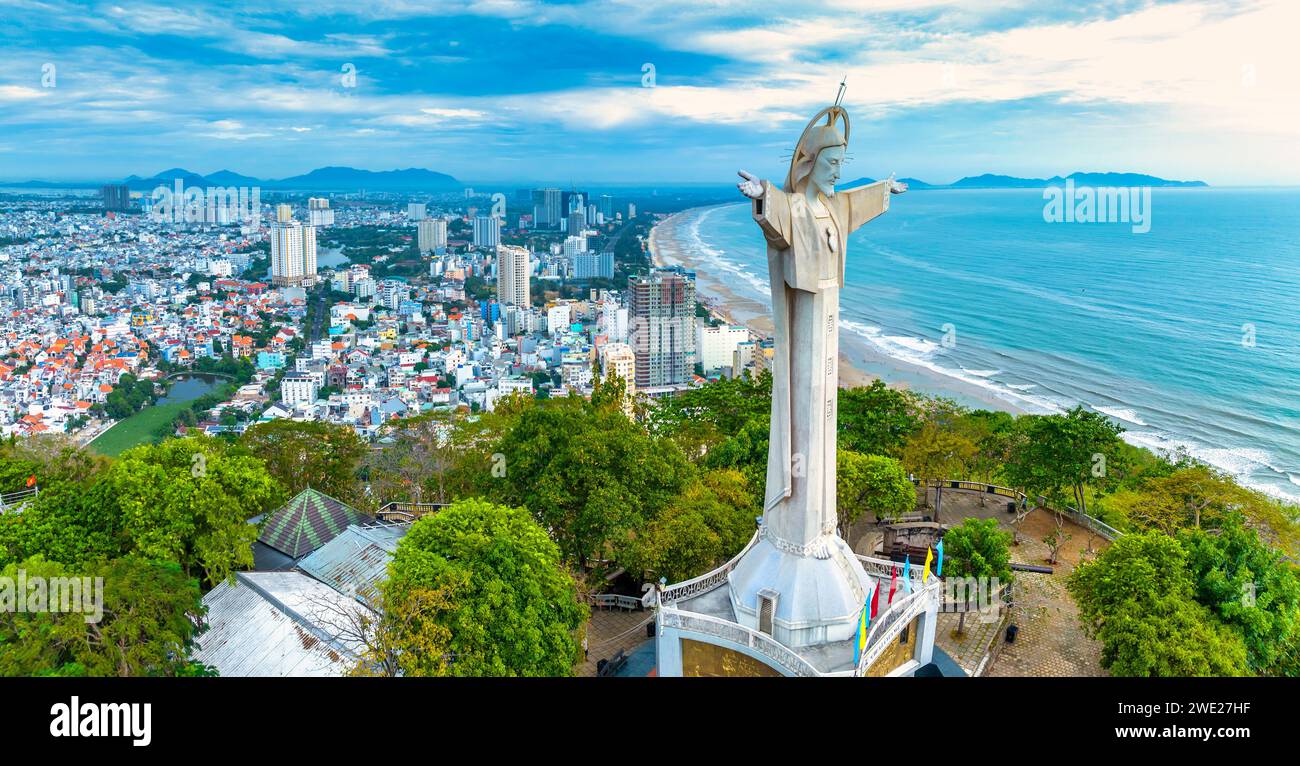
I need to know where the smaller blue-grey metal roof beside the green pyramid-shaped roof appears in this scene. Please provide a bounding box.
[298,524,411,602]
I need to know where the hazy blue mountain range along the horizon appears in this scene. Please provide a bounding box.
[0,165,1209,191]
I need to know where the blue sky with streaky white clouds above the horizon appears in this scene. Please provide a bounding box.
[0,0,1300,185]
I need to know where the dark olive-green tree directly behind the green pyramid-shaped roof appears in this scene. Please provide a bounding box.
[239,420,367,501]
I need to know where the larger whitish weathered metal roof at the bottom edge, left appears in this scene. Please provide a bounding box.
[194,572,365,678]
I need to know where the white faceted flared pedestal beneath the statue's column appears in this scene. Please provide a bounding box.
[727,529,871,649]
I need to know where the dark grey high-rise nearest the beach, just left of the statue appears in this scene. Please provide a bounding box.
[628,269,696,389]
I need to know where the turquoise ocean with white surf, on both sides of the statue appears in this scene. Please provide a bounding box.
[676,189,1300,502]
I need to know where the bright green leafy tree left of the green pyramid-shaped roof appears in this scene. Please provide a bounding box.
[92,436,285,584]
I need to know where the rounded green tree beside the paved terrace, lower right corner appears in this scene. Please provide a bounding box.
[1069,532,1249,676]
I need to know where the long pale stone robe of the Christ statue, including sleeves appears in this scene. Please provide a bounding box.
[754,181,889,555]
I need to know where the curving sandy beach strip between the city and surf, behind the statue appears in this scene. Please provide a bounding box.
[650,202,1026,414]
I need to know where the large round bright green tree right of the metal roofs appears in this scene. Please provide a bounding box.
[384,498,588,676]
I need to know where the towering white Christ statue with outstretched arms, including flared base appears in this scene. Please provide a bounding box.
[728,101,907,646]
